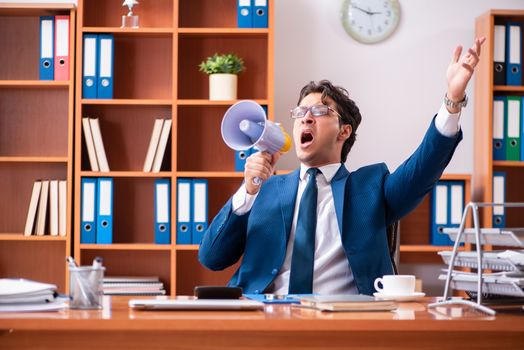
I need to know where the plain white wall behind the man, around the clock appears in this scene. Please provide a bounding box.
[275,0,524,173]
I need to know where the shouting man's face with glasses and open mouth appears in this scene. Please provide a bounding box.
[293,92,351,167]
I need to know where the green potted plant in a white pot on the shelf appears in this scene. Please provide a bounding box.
[199,53,245,101]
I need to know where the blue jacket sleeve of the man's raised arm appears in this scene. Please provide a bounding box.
[384,118,462,225]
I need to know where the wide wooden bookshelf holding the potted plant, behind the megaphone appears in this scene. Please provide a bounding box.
[74,0,274,295]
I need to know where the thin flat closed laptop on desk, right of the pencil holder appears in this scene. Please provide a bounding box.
[129,299,264,311]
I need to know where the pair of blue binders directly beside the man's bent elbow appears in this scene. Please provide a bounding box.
[176,179,208,244]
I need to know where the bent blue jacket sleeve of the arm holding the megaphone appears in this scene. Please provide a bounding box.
[198,199,249,271]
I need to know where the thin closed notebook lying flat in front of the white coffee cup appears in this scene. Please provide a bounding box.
[300,294,397,311]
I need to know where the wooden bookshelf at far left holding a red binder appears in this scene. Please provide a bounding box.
[0,2,76,293]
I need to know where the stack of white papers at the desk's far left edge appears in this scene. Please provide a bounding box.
[0,278,67,312]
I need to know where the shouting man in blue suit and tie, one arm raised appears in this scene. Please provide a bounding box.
[199,38,485,294]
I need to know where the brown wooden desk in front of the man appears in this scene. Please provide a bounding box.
[0,298,524,350]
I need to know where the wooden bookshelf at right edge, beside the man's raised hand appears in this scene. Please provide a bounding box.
[473,10,524,227]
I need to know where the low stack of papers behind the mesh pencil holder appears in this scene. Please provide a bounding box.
[103,276,166,295]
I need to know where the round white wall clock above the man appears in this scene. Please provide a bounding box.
[342,0,400,44]
